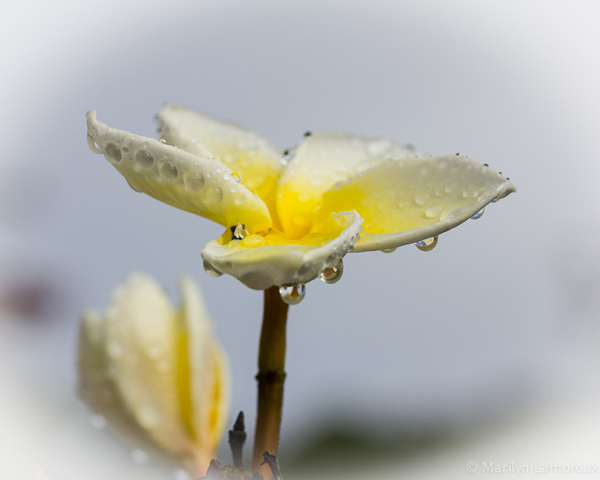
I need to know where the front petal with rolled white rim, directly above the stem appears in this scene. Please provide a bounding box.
[202,212,362,290]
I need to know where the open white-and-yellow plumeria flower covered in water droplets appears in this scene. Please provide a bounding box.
[87,106,515,303]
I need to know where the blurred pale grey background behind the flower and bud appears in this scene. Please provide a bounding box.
[0,0,600,480]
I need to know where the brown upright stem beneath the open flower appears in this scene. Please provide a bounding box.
[252,287,289,478]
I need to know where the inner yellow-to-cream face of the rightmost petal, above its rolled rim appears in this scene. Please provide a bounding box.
[312,156,506,237]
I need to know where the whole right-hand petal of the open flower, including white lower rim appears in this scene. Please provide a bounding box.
[313,156,516,252]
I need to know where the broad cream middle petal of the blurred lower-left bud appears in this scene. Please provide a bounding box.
[99,274,193,455]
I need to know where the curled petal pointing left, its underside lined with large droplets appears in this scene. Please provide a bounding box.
[87,111,271,232]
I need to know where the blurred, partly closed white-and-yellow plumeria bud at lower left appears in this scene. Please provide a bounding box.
[78,273,230,476]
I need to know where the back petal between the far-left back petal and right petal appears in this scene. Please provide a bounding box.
[277,132,416,238]
